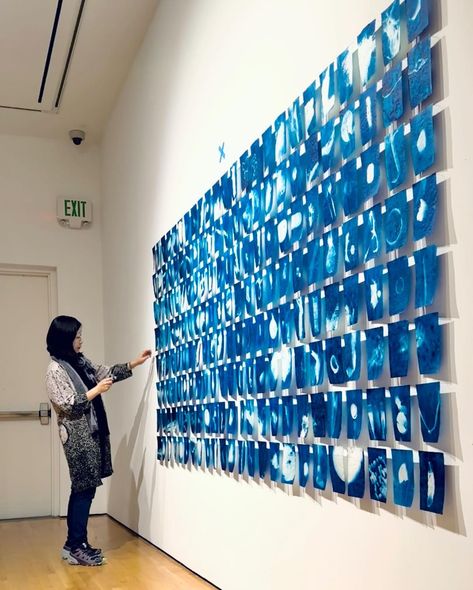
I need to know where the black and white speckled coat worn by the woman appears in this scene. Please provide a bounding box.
[46,360,132,492]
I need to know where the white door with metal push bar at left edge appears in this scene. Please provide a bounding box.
[0,267,58,519]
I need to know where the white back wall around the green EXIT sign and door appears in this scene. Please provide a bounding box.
[0,135,106,514]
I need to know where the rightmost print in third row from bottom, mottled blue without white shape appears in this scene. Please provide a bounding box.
[415,313,442,375]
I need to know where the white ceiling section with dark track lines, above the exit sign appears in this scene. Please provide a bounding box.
[0,0,159,143]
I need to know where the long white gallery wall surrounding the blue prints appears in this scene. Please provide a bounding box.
[103,0,473,590]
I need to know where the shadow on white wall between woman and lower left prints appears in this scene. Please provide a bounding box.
[108,362,156,544]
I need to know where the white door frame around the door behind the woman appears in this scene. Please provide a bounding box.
[0,263,61,516]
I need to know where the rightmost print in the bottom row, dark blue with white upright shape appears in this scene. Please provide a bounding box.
[419,451,445,514]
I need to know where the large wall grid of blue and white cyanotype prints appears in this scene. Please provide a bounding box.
[153,0,445,513]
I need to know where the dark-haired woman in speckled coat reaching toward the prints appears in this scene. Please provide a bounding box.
[46,316,151,565]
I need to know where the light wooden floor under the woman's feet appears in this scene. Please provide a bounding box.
[0,516,214,590]
